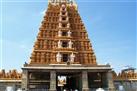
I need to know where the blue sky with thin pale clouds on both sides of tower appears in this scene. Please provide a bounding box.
[0,0,137,72]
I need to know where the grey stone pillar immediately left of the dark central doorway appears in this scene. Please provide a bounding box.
[49,71,56,91]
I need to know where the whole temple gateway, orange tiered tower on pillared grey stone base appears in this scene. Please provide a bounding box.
[0,0,137,91]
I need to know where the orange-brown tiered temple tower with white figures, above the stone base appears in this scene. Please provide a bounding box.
[30,0,97,65]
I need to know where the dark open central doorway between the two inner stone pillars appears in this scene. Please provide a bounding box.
[56,72,82,91]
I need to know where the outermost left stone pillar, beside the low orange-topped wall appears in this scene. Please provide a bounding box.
[21,69,29,91]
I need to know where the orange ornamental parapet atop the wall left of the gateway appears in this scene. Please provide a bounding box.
[0,69,22,80]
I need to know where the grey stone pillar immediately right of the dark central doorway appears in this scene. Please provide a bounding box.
[82,71,89,91]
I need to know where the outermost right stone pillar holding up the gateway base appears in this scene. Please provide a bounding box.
[106,71,114,91]
